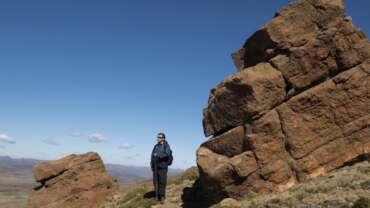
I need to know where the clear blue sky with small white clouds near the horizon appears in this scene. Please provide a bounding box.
[0,0,370,168]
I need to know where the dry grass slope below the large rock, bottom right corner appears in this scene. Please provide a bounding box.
[241,162,370,208]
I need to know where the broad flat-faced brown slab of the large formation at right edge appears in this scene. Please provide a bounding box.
[277,64,370,180]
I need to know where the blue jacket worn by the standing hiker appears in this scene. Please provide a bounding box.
[150,141,172,171]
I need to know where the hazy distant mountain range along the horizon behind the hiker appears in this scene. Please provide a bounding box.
[0,156,183,182]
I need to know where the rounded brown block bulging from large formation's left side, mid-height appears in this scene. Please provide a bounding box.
[203,63,285,136]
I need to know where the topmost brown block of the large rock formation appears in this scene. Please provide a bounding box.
[233,0,370,91]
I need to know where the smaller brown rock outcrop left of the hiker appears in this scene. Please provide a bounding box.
[28,152,118,208]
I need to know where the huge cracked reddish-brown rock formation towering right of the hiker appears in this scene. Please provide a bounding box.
[197,0,370,201]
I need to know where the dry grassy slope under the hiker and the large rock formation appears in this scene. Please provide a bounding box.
[104,161,370,208]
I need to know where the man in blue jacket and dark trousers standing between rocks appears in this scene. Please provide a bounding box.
[150,133,173,203]
